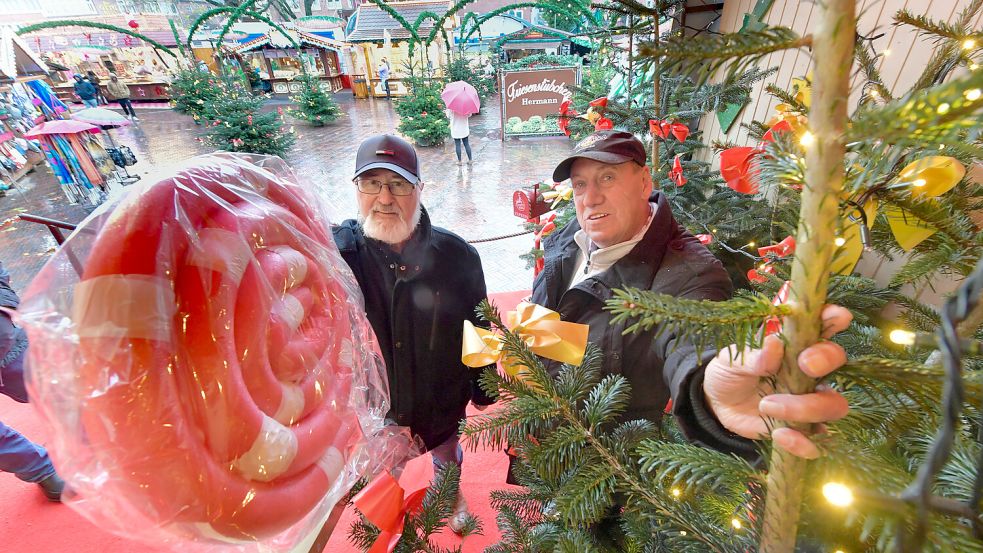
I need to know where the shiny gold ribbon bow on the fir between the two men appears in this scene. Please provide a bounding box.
[461,302,589,378]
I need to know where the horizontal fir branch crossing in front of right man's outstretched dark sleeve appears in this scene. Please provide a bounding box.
[605,289,789,350]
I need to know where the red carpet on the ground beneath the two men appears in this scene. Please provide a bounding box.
[0,291,529,553]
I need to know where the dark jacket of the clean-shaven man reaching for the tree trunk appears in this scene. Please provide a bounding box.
[532,192,753,454]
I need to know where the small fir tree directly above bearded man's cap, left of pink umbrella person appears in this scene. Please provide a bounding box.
[396,77,450,146]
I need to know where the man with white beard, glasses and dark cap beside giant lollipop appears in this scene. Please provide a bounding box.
[333,135,493,532]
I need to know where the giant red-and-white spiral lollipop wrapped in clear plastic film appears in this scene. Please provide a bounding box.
[18,153,412,550]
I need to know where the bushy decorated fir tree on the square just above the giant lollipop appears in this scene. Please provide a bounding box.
[207,74,295,156]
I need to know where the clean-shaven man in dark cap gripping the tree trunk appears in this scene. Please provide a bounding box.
[532,131,851,458]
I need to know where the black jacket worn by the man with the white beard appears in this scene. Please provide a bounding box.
[332,211,492,449]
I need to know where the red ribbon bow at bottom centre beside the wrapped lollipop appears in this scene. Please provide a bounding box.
[352,463,428,553]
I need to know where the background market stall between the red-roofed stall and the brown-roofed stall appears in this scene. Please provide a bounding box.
[231,29,350,94]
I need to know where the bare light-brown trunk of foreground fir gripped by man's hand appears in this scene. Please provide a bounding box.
[759,0,857,553]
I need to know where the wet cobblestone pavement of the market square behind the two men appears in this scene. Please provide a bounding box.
[0,92,572,292]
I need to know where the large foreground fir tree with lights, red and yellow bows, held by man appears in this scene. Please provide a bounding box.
[464,0,983,552]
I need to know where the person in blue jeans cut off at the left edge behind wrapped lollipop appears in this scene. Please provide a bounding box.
[0,263,65,501]
